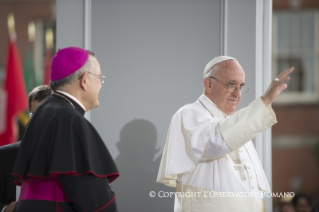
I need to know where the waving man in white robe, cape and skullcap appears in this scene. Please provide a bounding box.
[157,56,293,212]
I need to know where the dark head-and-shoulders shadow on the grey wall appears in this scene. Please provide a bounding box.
[112,119,175,212]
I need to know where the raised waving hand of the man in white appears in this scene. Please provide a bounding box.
[261,67,294,106]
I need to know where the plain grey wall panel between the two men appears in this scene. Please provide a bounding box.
[91,0,220,212]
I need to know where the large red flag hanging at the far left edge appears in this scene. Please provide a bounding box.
[0,35,28,146]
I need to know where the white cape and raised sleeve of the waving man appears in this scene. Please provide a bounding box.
[157,98,276,186]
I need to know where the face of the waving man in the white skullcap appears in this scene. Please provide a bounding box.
[207,60,245,115]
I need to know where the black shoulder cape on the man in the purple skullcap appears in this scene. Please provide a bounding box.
[12,94,119,185]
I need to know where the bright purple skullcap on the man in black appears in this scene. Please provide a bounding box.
[51,47,89,81]
